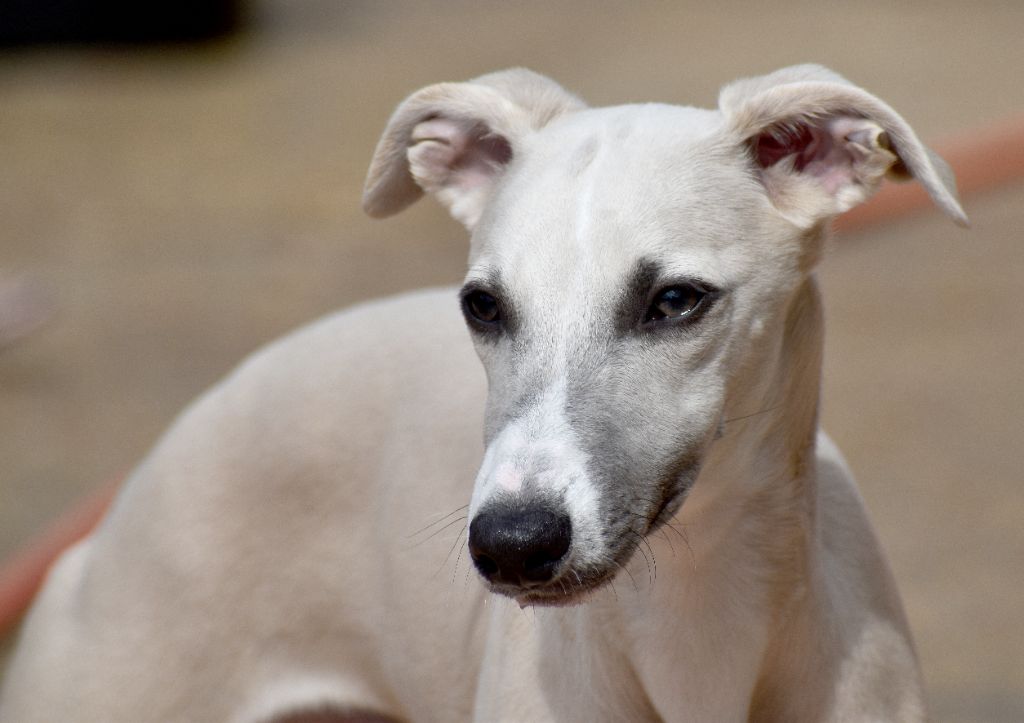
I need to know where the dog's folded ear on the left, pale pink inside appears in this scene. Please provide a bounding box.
[362,68,585,228]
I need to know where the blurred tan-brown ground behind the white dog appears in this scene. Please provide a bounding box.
[0,0,1024,723]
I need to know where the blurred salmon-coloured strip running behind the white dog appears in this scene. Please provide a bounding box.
[0,116,1024,635]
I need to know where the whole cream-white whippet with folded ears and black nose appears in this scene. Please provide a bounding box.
[0,66,966,723]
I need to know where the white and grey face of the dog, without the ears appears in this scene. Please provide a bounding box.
[461,105,801,602]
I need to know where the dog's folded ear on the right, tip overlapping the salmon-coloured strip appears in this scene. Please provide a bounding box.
[719,65,968,227]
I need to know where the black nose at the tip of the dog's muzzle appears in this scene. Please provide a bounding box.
[469,506,572,587]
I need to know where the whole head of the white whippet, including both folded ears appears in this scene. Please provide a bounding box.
[366,67,962,604]
